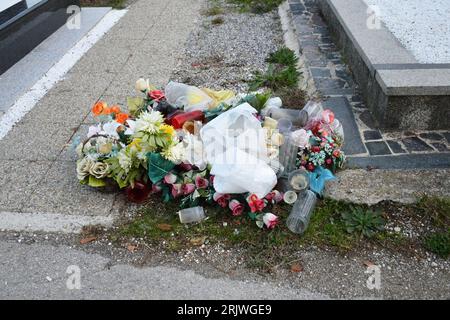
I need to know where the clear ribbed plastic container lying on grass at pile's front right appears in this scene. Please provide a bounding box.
[286,190,317,234]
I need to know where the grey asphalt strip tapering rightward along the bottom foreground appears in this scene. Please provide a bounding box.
[0,241,327,300]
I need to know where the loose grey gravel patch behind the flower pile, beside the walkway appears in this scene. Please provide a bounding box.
[172,4,283,92]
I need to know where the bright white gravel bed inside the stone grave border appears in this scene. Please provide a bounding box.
[364,0,450,63]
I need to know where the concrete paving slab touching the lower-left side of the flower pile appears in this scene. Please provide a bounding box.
[22,161,116,216]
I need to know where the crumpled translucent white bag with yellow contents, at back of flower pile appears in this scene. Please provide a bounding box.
[165,81,214,112]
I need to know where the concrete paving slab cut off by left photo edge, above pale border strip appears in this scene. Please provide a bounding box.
[0,160,51,211]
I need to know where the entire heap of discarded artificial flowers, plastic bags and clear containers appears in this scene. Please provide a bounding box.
[76,79,345,234]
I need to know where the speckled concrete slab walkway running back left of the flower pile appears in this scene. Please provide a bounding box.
[0,0,203,231]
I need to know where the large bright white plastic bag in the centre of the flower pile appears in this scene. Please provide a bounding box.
[200,103,277,198]
